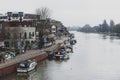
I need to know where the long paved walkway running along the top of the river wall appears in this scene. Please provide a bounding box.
[0,37,67,69]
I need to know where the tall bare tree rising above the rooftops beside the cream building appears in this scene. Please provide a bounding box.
[36,7,50,48]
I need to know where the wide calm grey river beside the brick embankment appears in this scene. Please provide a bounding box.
[0,32,120,80]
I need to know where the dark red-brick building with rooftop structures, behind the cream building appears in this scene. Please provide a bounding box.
[0,12,37,46]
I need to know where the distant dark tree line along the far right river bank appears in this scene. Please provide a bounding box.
[78,20,120,35]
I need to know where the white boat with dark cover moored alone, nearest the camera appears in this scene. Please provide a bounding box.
[17,59,37,72]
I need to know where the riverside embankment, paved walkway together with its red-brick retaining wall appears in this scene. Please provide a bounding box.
[0,37,68,76]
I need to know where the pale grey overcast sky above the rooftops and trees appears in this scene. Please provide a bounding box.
[0,0,120,26]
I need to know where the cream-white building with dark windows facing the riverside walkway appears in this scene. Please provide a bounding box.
[4,27,36,49]
